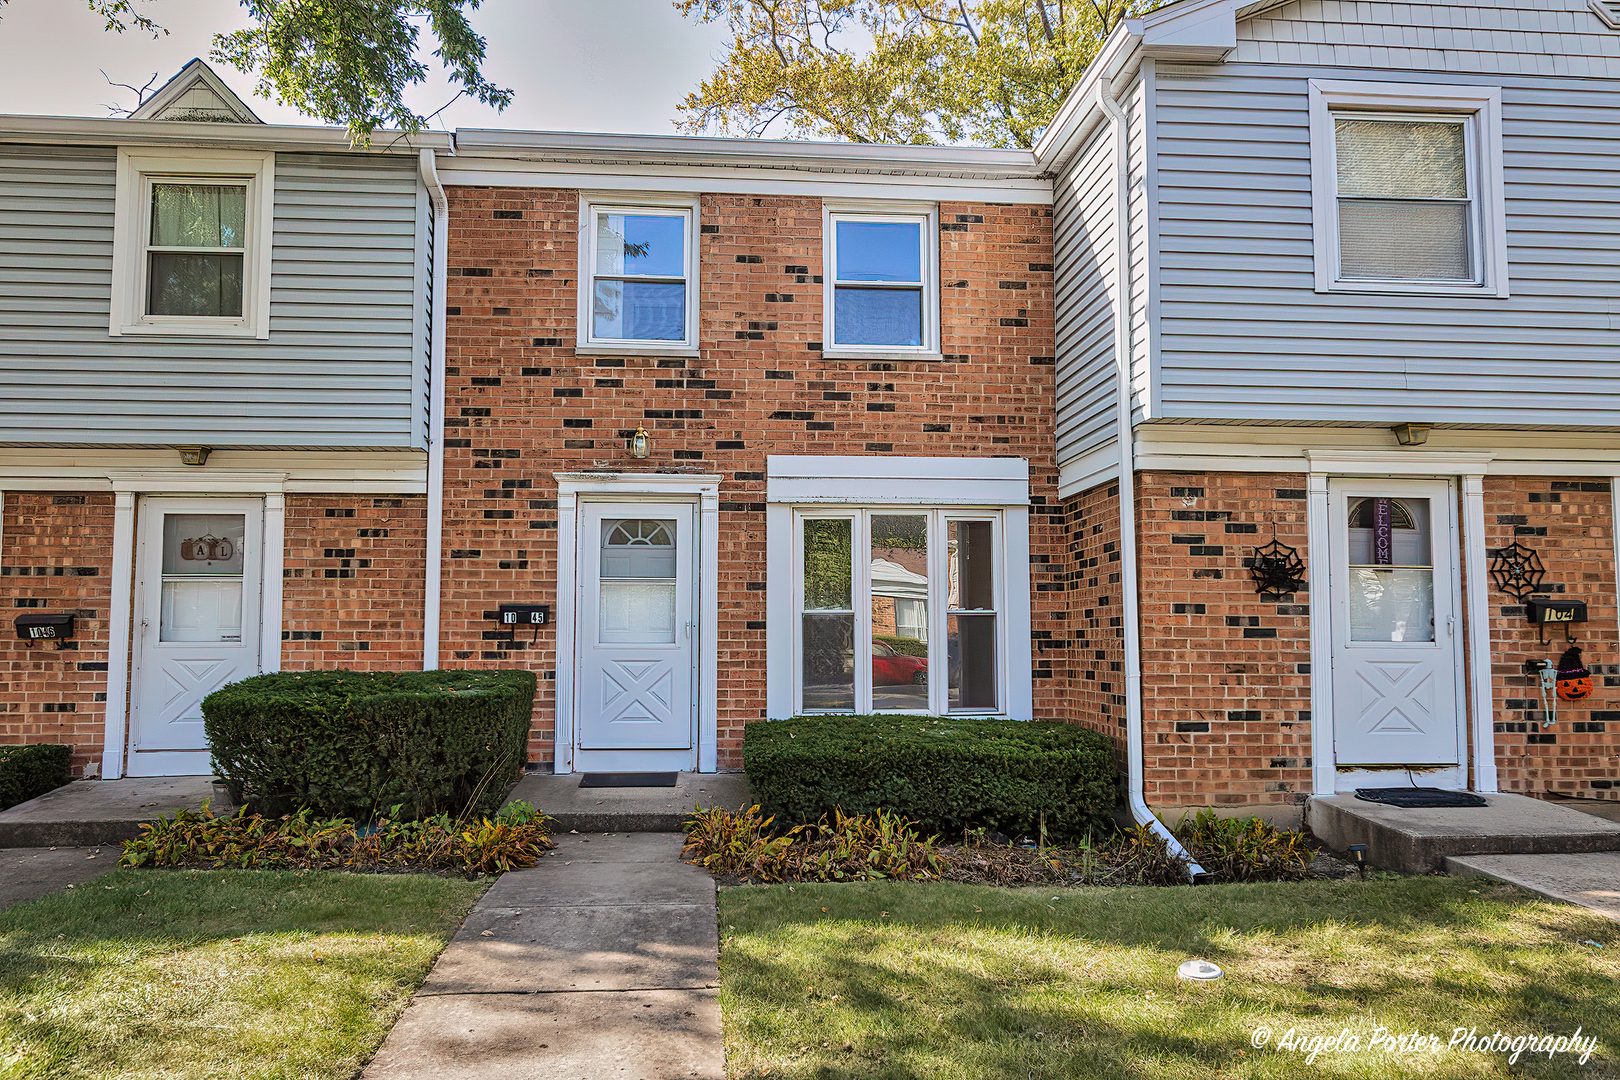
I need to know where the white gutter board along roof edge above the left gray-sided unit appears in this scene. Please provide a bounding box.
[0,115,454,159]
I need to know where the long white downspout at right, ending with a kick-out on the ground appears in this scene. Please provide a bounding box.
[1097,80,1209,884]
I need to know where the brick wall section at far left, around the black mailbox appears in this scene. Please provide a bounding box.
[0,491,113,776]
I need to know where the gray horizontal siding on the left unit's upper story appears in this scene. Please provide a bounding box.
[0,146,426,449]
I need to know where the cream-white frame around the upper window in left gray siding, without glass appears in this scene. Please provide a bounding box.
[107,149,275,338]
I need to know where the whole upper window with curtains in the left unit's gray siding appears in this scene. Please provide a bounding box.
[110,145,275,337]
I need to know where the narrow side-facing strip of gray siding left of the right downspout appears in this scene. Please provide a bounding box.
[1051,125,1116,465]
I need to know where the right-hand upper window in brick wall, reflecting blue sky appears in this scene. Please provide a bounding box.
[823,207,940,356]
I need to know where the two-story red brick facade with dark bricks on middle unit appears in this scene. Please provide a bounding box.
[444,186,1066,767]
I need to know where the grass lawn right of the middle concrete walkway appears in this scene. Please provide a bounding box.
[721,876,1620,1080]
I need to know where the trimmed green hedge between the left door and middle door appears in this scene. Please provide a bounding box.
[203,670,535,821]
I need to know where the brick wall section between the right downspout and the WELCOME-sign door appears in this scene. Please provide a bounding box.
[1137,473,1312,811]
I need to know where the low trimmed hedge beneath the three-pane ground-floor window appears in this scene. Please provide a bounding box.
[742,716,1118,839]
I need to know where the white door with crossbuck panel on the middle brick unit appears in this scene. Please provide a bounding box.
[575,502,698,750]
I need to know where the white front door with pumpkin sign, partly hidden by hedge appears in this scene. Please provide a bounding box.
[126,499,264,776]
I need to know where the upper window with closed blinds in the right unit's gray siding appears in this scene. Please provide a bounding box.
[1311,79,1507,296]
